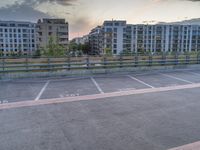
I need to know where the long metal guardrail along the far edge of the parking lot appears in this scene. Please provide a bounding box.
[0,55,200,74]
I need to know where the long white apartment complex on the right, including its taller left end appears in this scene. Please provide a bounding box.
[90,20,200,54]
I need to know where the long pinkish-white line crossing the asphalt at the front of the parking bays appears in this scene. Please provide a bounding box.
[0,83,200,110]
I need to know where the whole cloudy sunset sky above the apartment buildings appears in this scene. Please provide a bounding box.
[0,0,200,39]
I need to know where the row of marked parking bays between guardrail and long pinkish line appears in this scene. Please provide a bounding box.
[0,70,200,103]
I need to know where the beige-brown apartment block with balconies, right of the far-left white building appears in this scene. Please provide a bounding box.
[37,19,69,48]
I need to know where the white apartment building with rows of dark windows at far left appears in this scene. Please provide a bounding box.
[0,21,37,56]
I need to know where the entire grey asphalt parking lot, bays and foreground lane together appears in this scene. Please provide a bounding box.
[0,70,200,150]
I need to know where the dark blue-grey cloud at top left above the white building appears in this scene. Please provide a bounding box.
[0,0,77,22]
